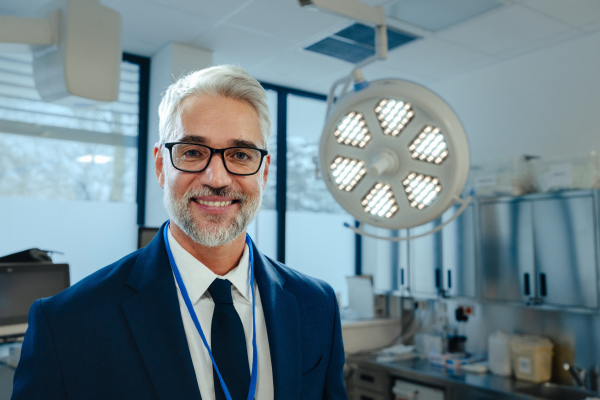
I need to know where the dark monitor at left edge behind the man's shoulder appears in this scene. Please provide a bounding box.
[0,263,70,336]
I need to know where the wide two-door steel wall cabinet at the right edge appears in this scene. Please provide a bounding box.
[479,191,598,309]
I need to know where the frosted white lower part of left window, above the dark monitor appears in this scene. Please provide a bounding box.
[0,197,137,284]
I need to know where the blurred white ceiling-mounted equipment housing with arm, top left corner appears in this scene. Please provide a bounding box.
[0,0,122,107]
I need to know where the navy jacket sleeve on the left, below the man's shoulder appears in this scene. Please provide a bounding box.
[11,300,66,400]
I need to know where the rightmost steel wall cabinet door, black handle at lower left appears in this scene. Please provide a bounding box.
[532,195,598,308]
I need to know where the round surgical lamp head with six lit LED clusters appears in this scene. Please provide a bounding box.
[320,79,469,229]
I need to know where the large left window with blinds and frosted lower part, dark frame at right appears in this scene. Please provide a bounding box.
[0,53,149,283]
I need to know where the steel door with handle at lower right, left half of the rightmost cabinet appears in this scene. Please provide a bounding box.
[479,200,535,301]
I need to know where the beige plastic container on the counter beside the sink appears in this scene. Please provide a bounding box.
[510,335,553,383]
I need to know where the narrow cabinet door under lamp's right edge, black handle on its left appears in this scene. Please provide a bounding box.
[441,204,477,297]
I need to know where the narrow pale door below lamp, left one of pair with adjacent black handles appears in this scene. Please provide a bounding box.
[409,220,442,298]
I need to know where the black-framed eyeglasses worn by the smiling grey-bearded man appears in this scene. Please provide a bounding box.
[162,142,269,175]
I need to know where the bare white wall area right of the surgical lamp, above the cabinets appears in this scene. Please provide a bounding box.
[429,29,600,163]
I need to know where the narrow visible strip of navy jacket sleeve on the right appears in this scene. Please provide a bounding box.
[323,289,348,400]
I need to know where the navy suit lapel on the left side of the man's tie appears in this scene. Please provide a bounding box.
[122,225,201,400]
